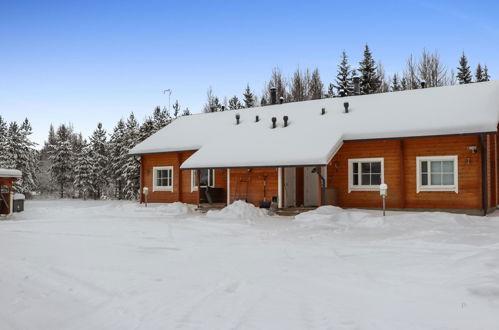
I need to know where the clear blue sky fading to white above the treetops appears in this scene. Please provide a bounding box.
[0,0,499,146]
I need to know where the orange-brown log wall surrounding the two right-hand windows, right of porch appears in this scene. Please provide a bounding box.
[328,136,492,209]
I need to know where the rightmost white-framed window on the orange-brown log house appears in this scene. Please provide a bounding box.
[416,156,458,193]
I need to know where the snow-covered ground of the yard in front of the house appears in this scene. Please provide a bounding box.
[0,201,499,329]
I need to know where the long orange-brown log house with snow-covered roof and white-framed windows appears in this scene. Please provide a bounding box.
[130,81,499,214]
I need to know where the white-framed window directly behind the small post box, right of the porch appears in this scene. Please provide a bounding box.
[348,158,384,192]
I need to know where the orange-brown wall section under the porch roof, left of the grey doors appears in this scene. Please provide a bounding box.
[230,168,278,205]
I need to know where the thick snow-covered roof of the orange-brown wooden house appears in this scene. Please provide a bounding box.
[130,81,499,169]
